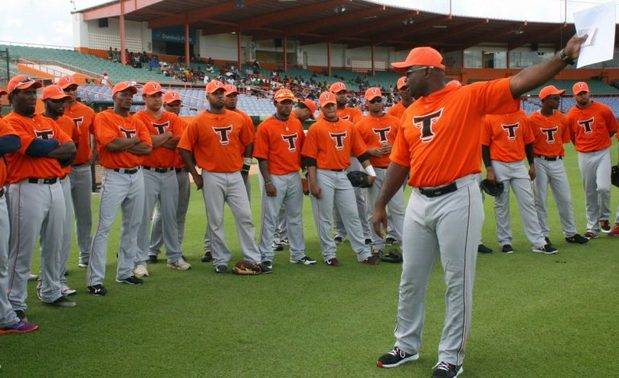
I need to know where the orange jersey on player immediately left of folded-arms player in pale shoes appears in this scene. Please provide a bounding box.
[94,109,152,169]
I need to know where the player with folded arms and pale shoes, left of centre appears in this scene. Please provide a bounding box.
[133,81,191,278]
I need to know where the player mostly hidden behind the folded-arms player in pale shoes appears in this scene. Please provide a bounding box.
[148,91,190,263]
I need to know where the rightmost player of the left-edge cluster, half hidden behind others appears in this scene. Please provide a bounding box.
[58,76,95,268]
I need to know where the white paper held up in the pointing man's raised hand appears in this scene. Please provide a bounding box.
[574,1,615,68]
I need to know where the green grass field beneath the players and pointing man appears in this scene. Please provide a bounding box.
[0,146,619,377]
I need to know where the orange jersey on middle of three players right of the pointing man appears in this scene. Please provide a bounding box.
[529,110,570,157]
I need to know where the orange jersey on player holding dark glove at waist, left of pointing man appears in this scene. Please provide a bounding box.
[301,117,367,170]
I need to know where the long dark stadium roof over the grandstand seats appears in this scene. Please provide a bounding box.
[78,0,617,51]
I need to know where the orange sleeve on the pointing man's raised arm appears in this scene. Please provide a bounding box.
[467,78,520,114]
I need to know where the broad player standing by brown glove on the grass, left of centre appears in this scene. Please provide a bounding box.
[178,80,261,275]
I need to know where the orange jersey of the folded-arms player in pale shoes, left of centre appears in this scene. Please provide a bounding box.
[134,110,184,168]
